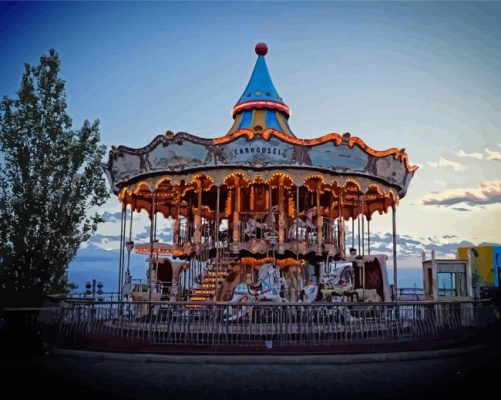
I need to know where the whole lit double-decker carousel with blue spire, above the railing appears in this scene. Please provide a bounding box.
[105,43,417,304]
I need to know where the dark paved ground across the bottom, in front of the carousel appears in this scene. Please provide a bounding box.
[1,346,501,400]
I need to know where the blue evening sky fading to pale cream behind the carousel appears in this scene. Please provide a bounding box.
[0,2,501,288]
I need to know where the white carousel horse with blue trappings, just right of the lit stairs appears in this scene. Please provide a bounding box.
[223,263,287,321]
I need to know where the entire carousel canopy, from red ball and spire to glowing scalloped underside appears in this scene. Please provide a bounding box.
[104,43,417,222]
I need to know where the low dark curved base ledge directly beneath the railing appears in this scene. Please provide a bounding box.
[52,340,487,365]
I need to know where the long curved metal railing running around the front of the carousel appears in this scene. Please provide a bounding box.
[40,300,492,347]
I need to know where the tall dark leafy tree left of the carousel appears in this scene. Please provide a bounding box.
[0,49,109,304]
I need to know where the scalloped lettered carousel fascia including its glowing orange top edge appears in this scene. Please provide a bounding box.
[105,129,417,197]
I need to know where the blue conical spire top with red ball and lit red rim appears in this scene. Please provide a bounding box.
[232,43,290,118]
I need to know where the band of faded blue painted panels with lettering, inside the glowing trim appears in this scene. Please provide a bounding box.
[108,134,412,197]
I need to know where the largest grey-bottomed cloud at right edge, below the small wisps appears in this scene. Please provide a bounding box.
[422,180,501,206]
